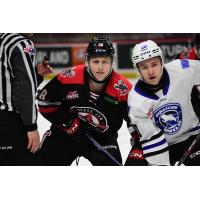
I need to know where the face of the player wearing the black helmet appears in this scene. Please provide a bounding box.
[88,56,112,81]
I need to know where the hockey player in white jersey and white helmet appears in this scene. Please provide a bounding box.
[126,40,200,165]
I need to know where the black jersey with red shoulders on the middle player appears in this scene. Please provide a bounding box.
[37,65,132,138]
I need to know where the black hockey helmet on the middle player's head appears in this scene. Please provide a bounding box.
[86,37,115,60]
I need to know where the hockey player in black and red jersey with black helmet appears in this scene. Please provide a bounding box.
[37,38,132,166]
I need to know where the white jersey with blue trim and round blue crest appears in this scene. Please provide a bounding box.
[128,60,200,165]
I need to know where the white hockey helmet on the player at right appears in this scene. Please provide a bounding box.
[132,40,164,68]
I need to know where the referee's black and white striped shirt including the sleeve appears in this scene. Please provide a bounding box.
[0,33,37,131]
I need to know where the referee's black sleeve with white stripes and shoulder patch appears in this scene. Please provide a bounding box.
[10,39,37,131]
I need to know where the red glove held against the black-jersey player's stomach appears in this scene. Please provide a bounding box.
[61,118,80,135]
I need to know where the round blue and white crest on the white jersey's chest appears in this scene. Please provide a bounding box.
[153,103,182,135]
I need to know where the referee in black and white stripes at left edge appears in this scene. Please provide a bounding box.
[0,33,40,166]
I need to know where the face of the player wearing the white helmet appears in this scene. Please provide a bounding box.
[138,58,163,85]
